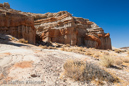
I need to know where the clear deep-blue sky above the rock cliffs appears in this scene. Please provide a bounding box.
[0,0,129,47]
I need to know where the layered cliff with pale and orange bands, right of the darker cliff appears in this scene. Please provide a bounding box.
[33,11,111,49]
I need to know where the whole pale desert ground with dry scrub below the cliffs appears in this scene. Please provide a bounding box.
[0,35,129,86]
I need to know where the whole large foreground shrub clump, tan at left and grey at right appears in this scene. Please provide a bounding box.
[63,60,118,82]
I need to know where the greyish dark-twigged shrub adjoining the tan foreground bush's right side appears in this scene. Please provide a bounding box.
[84,62,118,82]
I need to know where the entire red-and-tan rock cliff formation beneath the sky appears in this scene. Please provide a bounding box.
[0,3,112,49]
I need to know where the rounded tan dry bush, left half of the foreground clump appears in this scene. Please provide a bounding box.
[63,60,86,80]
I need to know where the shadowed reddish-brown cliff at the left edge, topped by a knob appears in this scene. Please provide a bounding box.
[0,3,36,44]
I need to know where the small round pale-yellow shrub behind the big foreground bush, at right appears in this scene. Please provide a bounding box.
[100,56,114,67]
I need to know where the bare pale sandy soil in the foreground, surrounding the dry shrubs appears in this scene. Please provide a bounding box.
[0,36,129,86]
